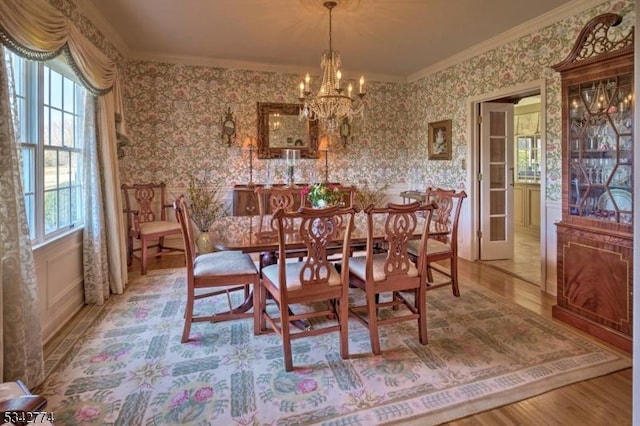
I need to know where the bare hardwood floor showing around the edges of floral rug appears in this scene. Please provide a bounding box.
[131,255,632,426]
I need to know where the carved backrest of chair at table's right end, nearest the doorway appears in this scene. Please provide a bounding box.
[426,188,467,246]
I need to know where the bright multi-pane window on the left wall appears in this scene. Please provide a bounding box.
[6,51,85,243]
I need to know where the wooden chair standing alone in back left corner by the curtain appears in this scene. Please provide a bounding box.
[120,183,182,275]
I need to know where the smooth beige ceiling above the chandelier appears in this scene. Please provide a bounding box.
[82,0,588,81]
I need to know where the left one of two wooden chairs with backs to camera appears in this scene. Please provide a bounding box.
[258,206,356,371]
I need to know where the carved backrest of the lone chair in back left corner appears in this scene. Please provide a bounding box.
[120,182,170,229]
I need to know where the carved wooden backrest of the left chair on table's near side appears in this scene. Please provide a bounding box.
[273,206,357,289]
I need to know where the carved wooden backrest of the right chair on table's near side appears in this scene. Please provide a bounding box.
[364,201,436,281]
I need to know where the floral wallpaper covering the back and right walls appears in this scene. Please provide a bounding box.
[49,0,635,204]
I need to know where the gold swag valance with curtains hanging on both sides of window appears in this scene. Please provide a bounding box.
[0,0,127,386]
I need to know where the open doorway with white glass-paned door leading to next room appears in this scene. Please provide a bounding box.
[472,84,546,288]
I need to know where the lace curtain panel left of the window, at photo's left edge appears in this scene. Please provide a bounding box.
[0,48,44,387]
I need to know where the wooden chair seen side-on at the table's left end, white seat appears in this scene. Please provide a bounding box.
[174,195,260,343]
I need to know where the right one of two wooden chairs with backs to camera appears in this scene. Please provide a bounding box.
[348,202,435,355]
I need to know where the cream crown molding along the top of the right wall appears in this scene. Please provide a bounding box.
[407,0,607,83]
